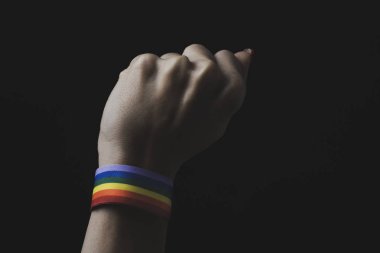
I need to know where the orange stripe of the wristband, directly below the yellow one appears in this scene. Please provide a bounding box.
[92,190,171,211]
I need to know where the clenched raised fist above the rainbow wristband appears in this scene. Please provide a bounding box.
[98,44,252,178]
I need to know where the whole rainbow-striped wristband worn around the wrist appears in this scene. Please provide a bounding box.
[91,164,173,218]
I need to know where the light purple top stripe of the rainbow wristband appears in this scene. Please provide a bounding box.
[95,164,173,186]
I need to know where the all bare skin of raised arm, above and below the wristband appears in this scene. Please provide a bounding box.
[82,44,252,253]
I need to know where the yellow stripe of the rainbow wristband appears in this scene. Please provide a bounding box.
[92,183,172,205]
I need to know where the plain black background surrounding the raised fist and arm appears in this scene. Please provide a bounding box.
[0,2,380,252]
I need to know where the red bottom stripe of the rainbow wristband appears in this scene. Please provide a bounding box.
[91,196,170,218]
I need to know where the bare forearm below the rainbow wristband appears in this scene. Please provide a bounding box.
[82,205,168,253]
